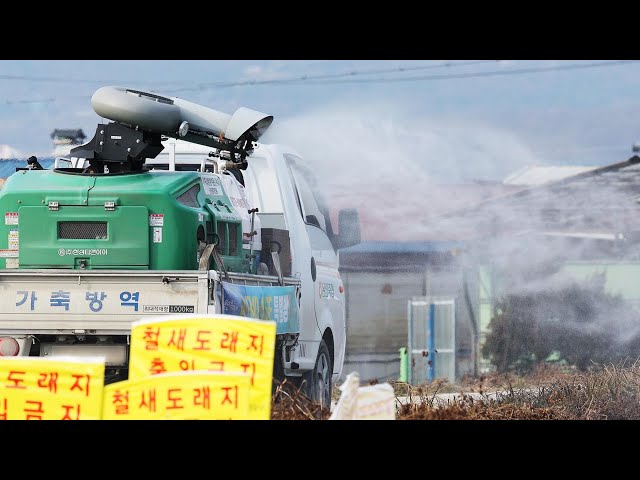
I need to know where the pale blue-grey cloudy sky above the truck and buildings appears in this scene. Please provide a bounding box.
[0,60,640,181]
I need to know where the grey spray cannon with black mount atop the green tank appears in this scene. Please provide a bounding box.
[72,87,273,173]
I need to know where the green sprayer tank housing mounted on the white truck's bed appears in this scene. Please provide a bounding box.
[0,170,248,271]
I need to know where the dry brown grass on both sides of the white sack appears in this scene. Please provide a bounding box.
[272,361,640,420]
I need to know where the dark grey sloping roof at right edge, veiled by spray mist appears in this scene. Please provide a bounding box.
[430,156,640,242]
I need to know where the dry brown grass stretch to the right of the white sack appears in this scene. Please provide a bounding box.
[396,362,640,420]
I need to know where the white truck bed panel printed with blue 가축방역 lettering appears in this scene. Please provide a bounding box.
[0,269,300,335]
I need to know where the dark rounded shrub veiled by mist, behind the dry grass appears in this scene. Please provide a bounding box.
[482,276,640,373]
